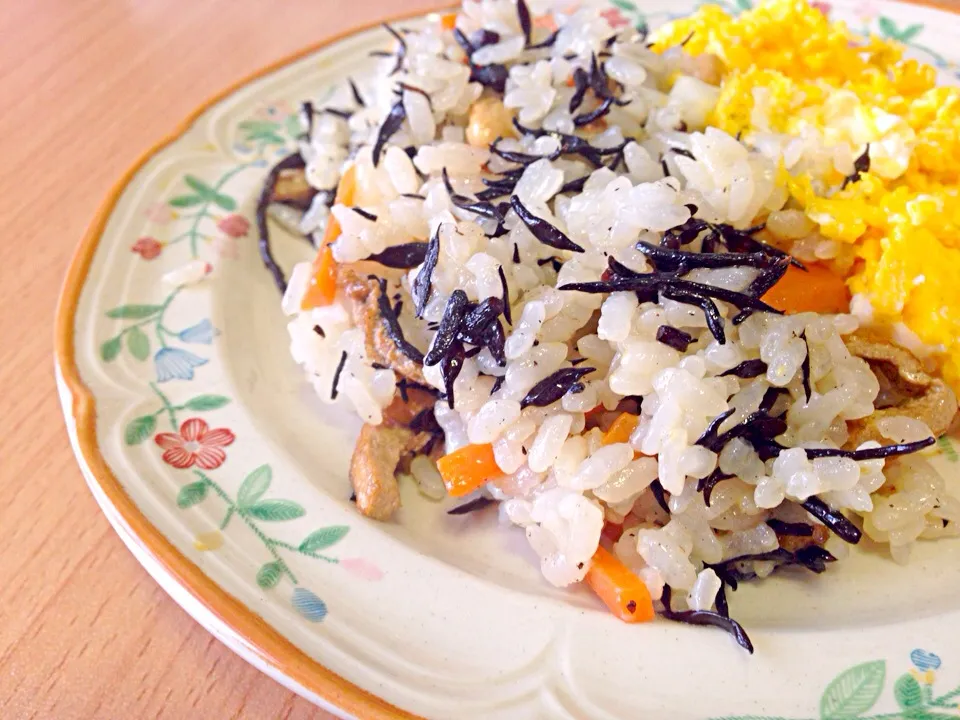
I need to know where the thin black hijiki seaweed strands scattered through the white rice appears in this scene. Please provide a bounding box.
[256,15,947,653]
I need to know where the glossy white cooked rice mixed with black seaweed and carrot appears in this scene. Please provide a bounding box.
[283,0,960,609]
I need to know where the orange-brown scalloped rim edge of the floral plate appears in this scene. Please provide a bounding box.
[54,0,960,720]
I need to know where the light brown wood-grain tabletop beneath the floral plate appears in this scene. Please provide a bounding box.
[0,0,437,720]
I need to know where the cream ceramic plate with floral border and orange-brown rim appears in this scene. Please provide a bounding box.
[56,0,960,720]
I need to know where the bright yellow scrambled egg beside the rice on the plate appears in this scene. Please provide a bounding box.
[654,0,960,388]
